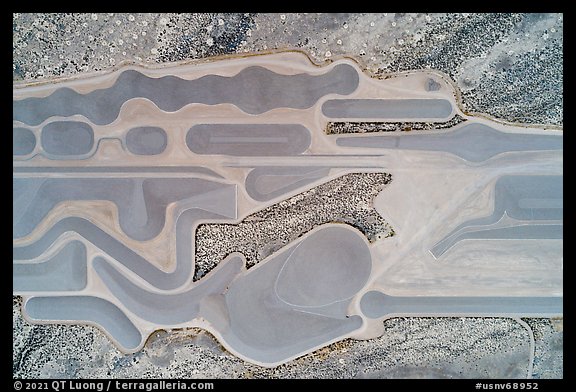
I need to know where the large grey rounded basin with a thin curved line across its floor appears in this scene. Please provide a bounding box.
[219,225,371,364]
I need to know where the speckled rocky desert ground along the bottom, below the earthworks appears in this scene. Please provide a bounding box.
[13,298,563,379]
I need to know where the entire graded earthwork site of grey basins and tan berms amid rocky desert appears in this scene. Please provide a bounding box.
[13,53,563,367]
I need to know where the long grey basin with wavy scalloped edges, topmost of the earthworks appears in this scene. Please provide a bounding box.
[12,64,359,125]
